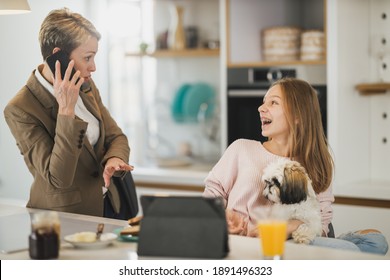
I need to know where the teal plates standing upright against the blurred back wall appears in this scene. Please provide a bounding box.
[171,83,215,122]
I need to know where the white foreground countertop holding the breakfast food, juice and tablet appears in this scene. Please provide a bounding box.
[0,202,389,260]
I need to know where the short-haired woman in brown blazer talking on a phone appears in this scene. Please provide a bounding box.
[4,8,133,217]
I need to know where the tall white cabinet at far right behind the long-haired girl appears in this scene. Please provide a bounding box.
[327,0,390,200]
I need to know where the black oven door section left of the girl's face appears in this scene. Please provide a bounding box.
[227,88,268,145]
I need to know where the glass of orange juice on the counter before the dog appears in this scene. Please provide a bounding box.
[257,205,287,260]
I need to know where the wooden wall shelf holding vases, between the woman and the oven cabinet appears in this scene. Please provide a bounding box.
[126,49,219,57]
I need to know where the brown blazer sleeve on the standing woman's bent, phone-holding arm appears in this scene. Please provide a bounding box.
[4,100,87,188]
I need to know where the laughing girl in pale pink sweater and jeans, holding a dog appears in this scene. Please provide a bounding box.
[203,78,387,254]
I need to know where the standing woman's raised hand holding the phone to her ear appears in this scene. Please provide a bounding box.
[53,60,84,118]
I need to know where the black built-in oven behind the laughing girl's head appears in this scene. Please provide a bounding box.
[227,68,327,145]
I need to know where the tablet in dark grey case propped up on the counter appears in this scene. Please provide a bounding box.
[138,196,229,259]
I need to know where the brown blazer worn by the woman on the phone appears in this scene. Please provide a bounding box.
[4,72,130,216]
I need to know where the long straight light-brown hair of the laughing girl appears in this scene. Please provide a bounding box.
[273,78,334,193]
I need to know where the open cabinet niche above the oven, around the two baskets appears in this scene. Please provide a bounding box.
[226,0,326,67]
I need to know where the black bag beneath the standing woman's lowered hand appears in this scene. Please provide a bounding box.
[112,171,139,220]
